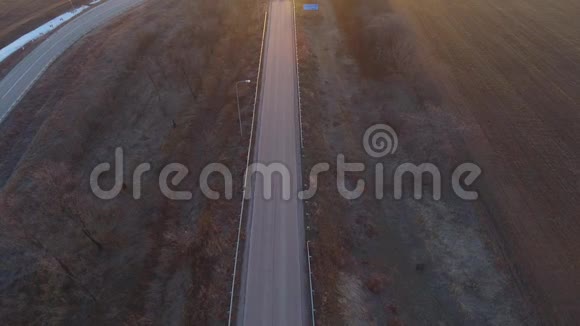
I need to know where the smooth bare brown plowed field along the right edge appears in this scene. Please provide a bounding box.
[393,0,580,323]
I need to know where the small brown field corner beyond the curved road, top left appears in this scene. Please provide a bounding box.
[0,0,90,48]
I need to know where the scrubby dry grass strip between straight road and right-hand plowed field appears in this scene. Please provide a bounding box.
[297,0,537,325]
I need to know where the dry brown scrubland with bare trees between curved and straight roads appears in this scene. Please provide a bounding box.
[0,0,263,325]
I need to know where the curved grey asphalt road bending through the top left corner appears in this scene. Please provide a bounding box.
[0,0,143,123]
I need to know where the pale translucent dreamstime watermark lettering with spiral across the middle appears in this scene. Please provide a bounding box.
[90,124,482,201]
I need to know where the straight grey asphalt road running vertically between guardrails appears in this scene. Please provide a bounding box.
[237,0,310,326]
